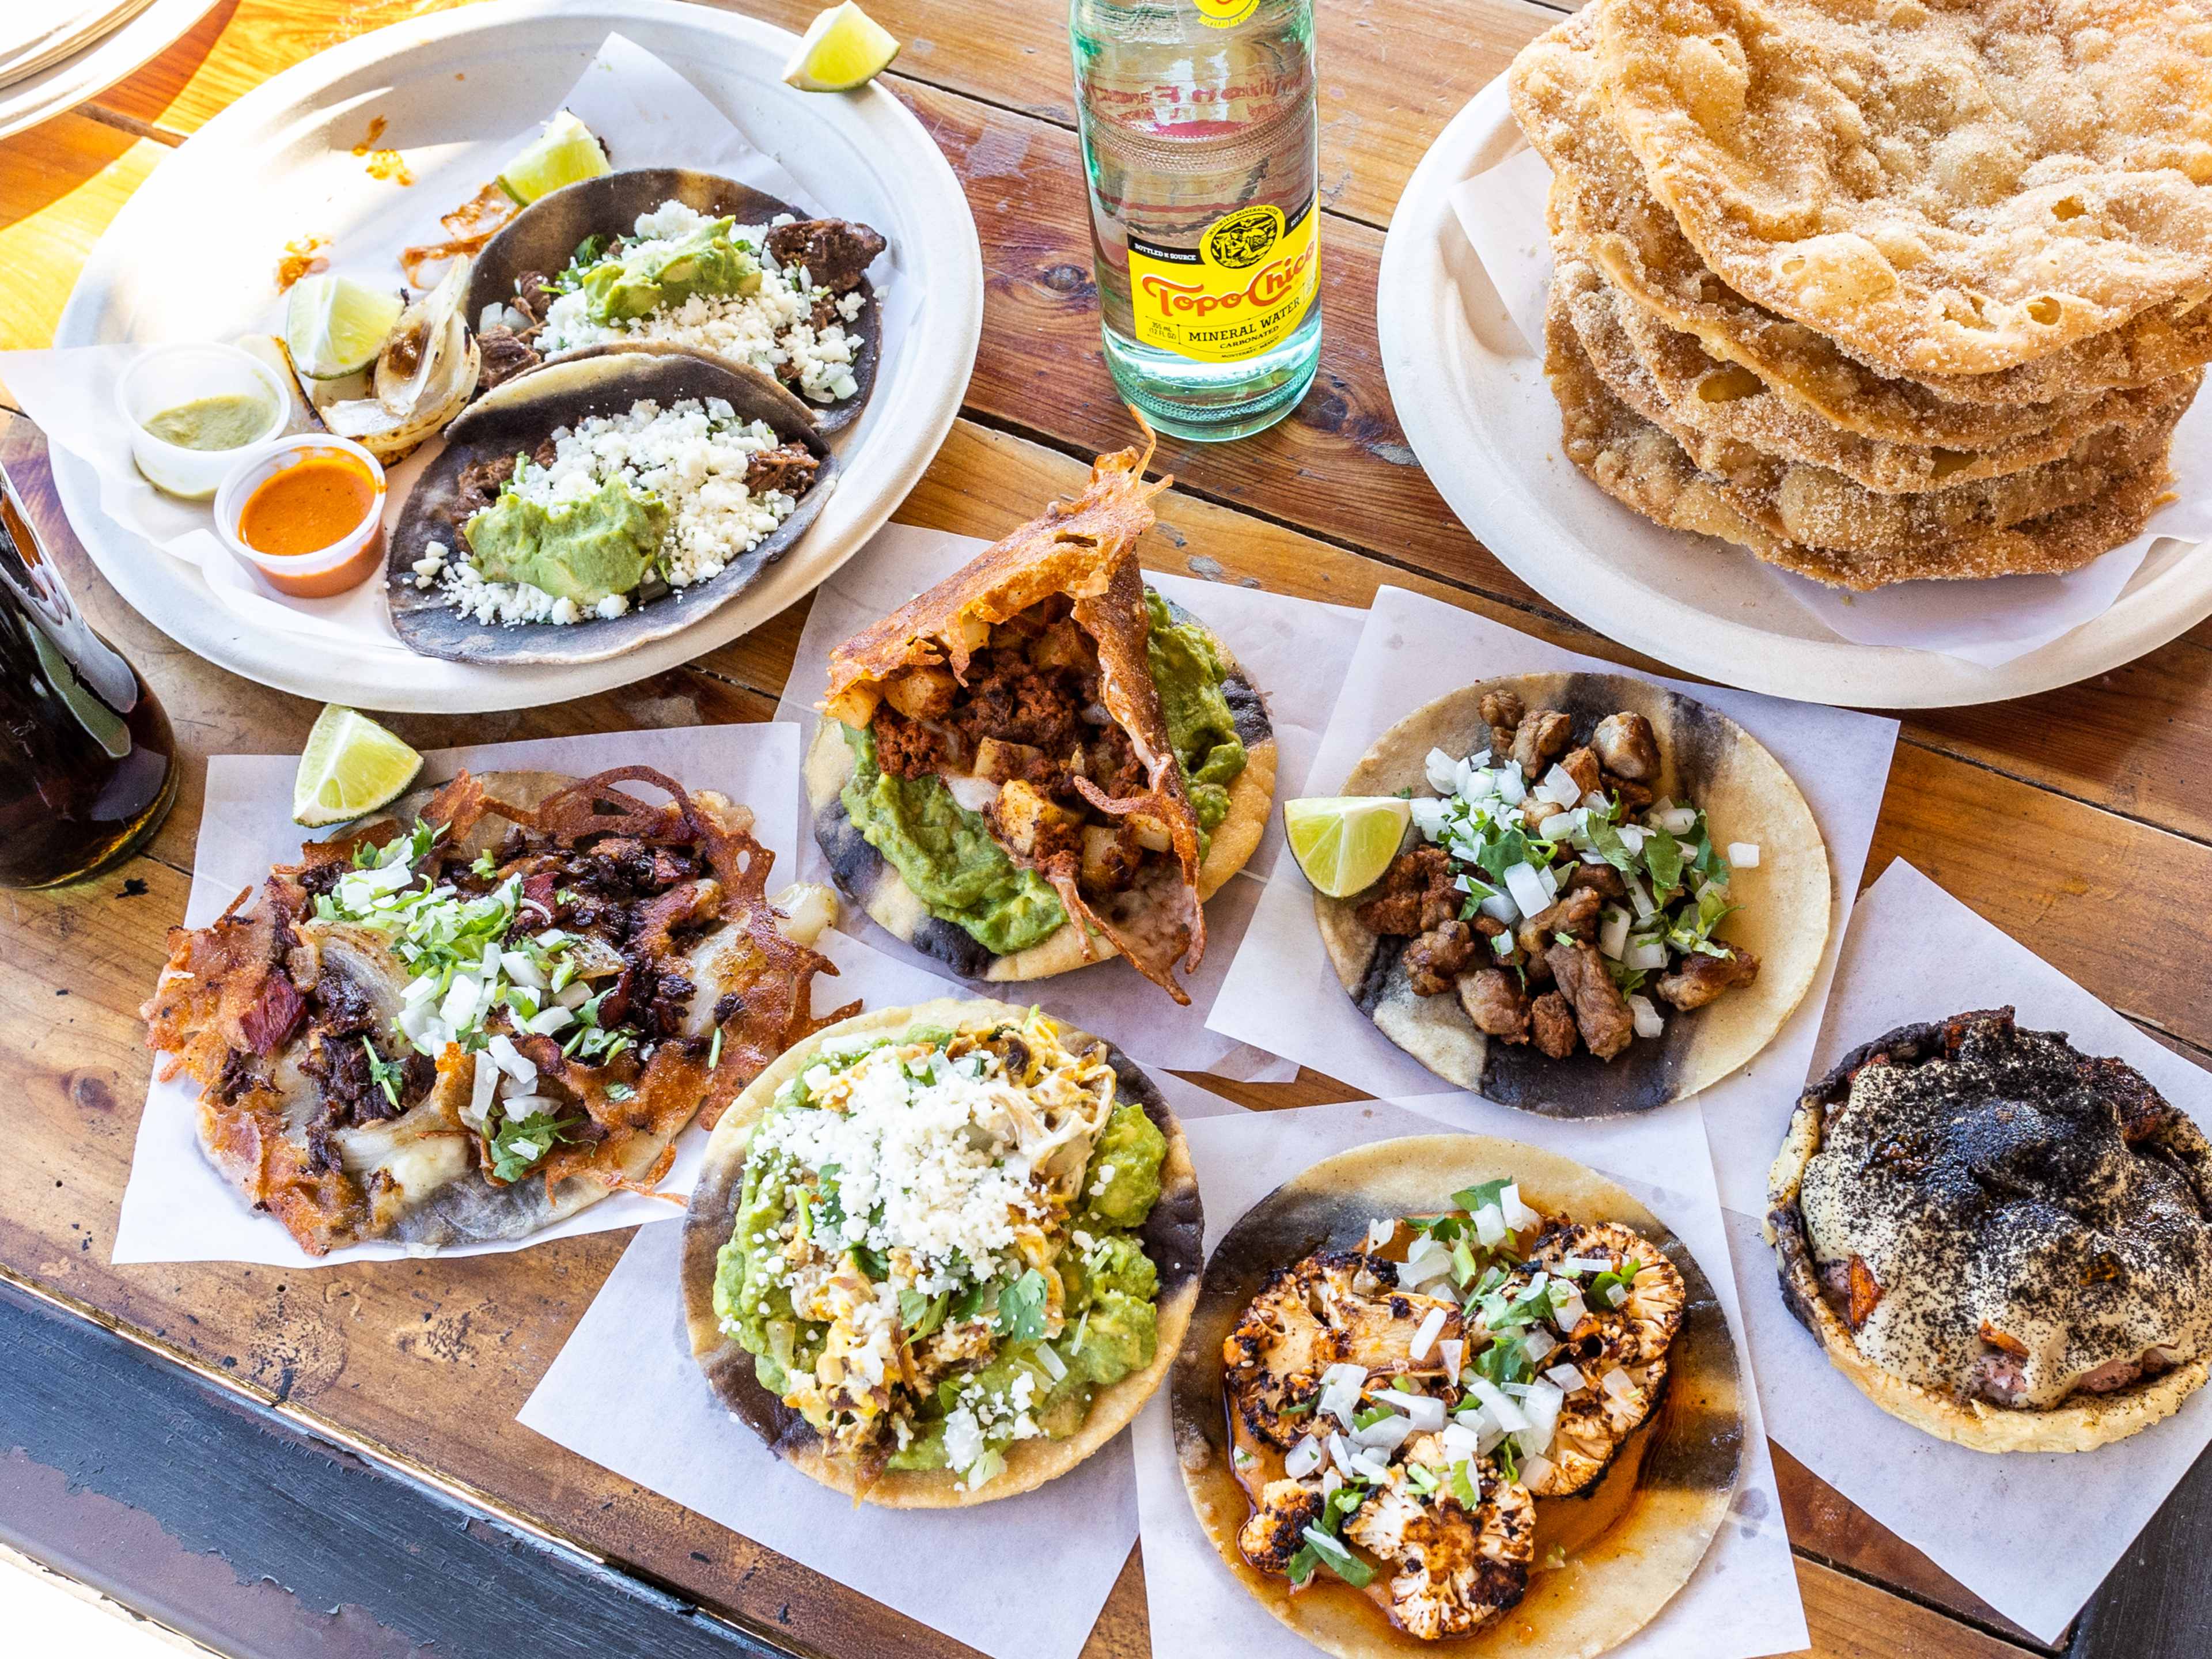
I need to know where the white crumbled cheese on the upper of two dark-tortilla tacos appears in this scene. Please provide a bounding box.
[537,201,867,403]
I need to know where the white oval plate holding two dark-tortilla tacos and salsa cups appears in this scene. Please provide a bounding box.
[55,0,982,712]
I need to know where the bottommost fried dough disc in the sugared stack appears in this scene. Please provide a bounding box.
[1544,308,2172,590]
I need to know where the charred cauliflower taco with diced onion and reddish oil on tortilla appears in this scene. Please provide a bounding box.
[1170,1135,1743,1659]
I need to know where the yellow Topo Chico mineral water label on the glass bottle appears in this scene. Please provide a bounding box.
[1128,201,1320,363]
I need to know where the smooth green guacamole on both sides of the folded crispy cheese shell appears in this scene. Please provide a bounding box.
[840,588,1245,956]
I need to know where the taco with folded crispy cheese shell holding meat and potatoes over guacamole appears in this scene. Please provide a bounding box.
[805,449,1274,1002]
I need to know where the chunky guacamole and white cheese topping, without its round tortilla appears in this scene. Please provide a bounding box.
[714,1011,1168,1484]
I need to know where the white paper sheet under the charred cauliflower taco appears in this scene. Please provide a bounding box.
[1135,1093,1809,1659]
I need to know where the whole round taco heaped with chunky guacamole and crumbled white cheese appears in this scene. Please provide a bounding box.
[684,998,1203,1509]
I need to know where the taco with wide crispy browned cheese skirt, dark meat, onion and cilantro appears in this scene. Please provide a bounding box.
[142,766,858,1256]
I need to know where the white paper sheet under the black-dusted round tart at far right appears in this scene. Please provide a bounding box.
[1712,861,2212,1641]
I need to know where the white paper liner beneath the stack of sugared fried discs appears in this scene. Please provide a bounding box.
[1451,146,2212,668]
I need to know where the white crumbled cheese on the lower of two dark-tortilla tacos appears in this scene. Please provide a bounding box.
[414,398,798,626]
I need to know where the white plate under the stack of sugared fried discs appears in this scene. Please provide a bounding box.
[1376,77,2212,708]
